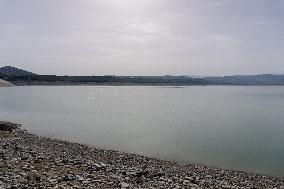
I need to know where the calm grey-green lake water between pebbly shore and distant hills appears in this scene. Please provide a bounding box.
[0,86,284,177]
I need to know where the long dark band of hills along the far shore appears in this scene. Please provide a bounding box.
[0,66,284,86]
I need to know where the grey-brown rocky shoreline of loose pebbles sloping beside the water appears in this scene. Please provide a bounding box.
[0,122,284,189]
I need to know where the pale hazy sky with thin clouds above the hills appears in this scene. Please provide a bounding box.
[0,0,284,75]
